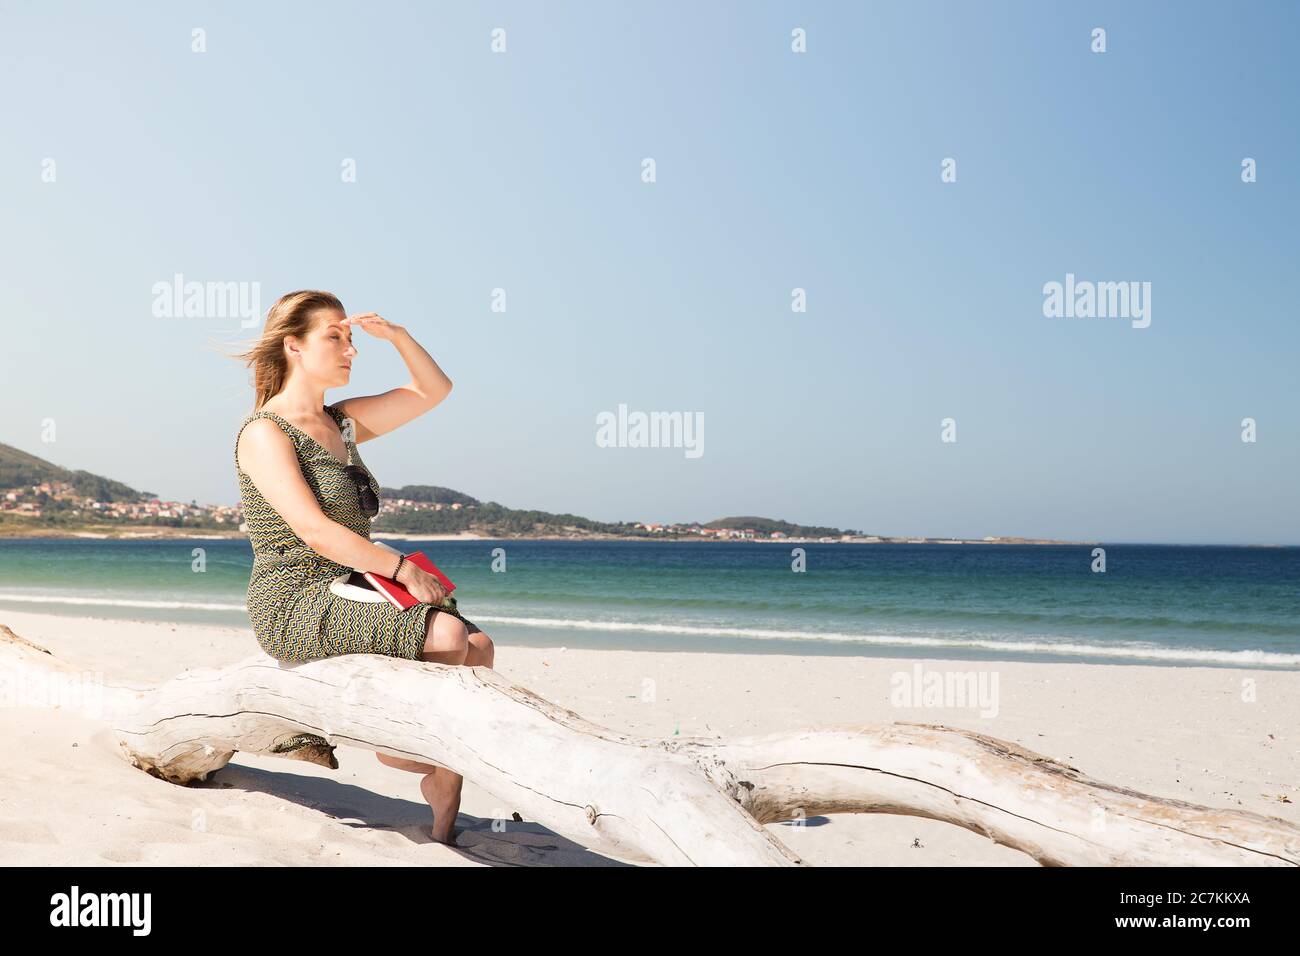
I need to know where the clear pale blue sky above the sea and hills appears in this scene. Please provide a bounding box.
[0,0,1300,544]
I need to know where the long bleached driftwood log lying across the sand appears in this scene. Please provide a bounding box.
[0,624,1300,866]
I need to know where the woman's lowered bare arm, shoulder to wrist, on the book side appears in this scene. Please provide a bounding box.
[237,419,404,578]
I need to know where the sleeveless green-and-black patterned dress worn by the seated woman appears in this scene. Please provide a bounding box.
[235,406,478,661]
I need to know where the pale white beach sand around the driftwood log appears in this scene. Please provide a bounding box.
[0,610,1300,866]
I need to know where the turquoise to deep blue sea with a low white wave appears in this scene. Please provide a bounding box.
[0,538,1300,667]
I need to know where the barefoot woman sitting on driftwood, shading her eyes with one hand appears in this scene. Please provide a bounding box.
[235,291,494,843]
